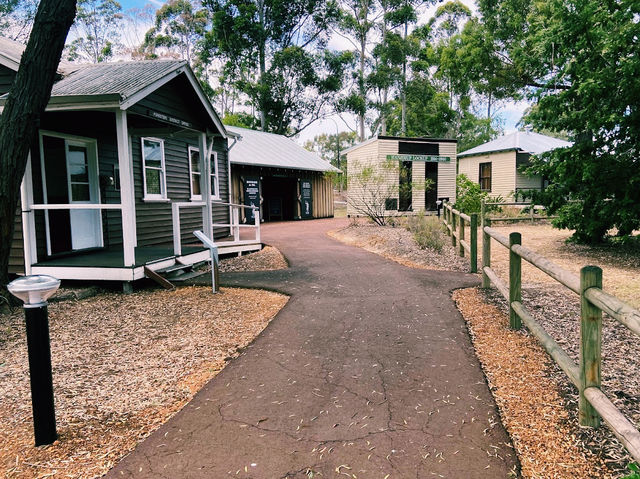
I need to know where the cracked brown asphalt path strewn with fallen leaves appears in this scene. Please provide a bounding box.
[108,220,517,479]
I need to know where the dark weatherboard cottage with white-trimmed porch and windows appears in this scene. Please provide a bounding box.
[0,36,260,289]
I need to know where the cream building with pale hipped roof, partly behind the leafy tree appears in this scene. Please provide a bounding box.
[458,131,571,199]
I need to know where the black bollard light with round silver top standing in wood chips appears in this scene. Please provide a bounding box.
[7,275,60,446]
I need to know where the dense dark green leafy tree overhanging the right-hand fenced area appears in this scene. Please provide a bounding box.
[479,0,640,243]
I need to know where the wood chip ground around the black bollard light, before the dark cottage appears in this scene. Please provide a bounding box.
[0,287,288,478]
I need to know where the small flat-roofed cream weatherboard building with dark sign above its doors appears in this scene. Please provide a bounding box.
[344,136,457,216]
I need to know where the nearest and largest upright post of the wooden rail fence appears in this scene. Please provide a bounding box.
[579,266,602,427]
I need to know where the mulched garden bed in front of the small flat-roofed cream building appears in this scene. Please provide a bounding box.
[328,222,469,272]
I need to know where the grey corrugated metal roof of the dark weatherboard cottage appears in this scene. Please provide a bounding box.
[51,60,186,100]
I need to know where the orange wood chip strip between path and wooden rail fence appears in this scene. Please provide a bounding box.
[453,288,624,479]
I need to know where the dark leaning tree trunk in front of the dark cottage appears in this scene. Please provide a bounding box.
[0,0,76,288]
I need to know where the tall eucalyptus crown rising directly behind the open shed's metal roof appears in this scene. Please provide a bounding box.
[202,0,350,135]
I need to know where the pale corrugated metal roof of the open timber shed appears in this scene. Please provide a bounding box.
[225,126,340,172]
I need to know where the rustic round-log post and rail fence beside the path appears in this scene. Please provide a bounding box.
[443,203,640,462]
